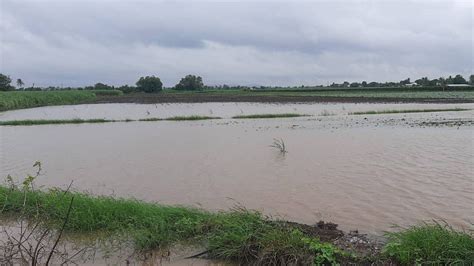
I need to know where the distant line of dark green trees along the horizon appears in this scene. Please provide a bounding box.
[0,73,474,93]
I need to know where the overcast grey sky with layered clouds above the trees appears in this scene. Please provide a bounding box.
[0,0,474,86]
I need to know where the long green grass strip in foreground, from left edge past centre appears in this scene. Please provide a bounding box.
[0,186,343,264]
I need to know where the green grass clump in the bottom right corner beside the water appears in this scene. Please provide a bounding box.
[384,223,474,265]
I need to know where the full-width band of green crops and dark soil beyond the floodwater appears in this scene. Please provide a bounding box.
[0,87,474,112]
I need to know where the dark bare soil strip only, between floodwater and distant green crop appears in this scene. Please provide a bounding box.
[95,93,474,104]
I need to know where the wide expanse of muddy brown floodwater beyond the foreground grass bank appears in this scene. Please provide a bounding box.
[0,103,474,234]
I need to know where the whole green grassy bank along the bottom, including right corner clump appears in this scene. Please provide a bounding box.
[0,183,474,265]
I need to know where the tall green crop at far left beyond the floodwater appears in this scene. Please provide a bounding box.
[0,90,96,112]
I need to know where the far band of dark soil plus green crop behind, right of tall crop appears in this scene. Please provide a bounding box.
[96,90,474,104]
